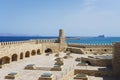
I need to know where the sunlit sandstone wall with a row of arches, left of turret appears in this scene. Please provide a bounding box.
[0,40,59,64]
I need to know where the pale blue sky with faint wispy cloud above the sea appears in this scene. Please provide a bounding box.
[0,0,120,36]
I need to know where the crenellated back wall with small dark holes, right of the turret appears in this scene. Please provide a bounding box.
[68,44,112,54]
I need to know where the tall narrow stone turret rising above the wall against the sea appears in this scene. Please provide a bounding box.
[58,29,67,51]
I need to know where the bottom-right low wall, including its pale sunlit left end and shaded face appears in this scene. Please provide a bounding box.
[61,69,113,80]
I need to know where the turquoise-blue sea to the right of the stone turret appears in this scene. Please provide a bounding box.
[67,37,120,44]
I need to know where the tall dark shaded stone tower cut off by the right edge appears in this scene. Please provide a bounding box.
[112,42,120,77]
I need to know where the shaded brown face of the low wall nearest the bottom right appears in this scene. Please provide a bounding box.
[74,69,113,77]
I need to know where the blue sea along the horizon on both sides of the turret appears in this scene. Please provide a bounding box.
[0,36,120,45]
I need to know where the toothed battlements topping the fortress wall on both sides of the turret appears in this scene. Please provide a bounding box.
[0,39,112,48]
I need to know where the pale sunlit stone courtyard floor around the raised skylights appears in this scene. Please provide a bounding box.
[0,53,116,80]
